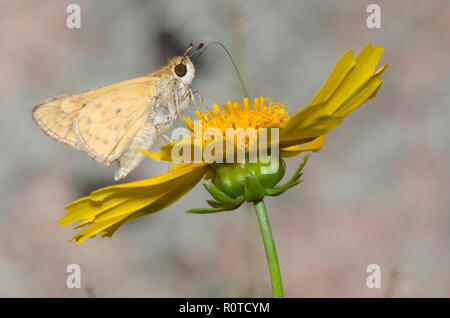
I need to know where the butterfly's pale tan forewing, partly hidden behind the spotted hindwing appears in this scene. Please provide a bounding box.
[30,77,156,149]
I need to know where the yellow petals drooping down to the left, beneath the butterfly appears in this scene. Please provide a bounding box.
[58,163,208,244]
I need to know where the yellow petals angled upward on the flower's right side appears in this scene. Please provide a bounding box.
[280,44,387,148]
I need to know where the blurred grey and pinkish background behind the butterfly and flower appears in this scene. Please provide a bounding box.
[0,0,450,297]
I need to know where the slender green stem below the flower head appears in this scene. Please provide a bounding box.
[253,199,284,298]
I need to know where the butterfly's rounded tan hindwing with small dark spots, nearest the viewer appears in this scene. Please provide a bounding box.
[74,81,158,165]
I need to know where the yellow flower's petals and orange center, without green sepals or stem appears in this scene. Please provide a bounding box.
[58,44,387,245]
